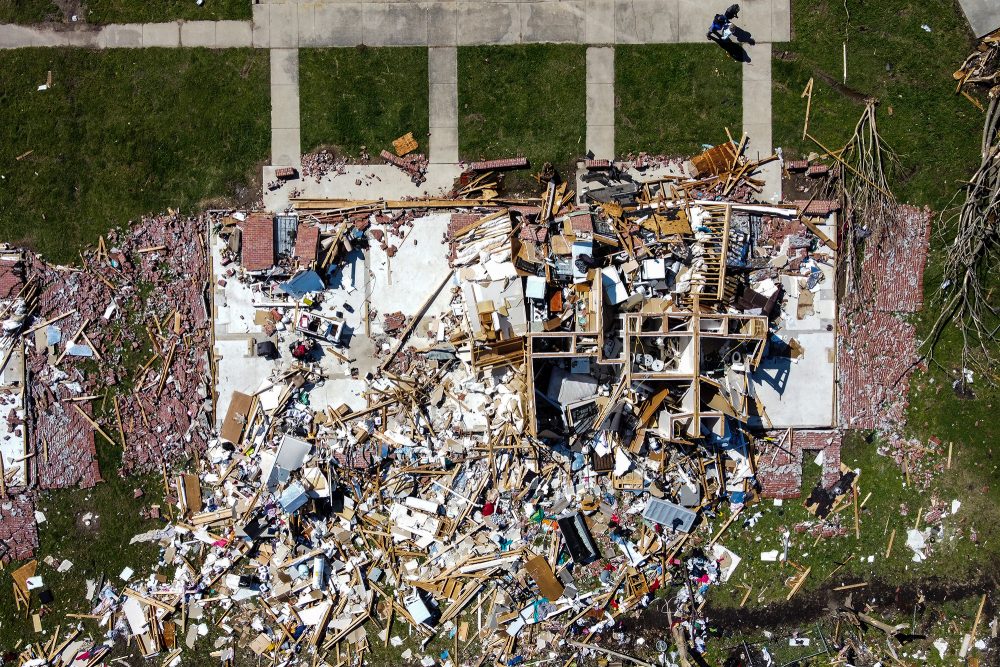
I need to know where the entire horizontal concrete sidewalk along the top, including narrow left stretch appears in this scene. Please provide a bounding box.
[0,0,792,49]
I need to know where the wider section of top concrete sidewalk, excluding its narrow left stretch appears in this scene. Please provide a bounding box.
[253,0,791,47]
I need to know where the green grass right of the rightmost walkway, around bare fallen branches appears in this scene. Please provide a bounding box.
[772,0,983,209]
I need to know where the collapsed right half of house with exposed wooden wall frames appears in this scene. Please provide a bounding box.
[449,159,836,496]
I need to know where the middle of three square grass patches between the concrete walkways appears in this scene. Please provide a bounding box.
[458,44,587,189]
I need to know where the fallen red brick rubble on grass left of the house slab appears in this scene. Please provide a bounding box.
[27,215,211,480]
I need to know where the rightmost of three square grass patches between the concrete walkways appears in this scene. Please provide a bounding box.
[615,44,743,155]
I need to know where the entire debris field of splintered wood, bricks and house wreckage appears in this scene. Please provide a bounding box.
[0,136,968,665]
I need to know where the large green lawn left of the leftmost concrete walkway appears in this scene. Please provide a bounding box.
[0,49,270,262]
